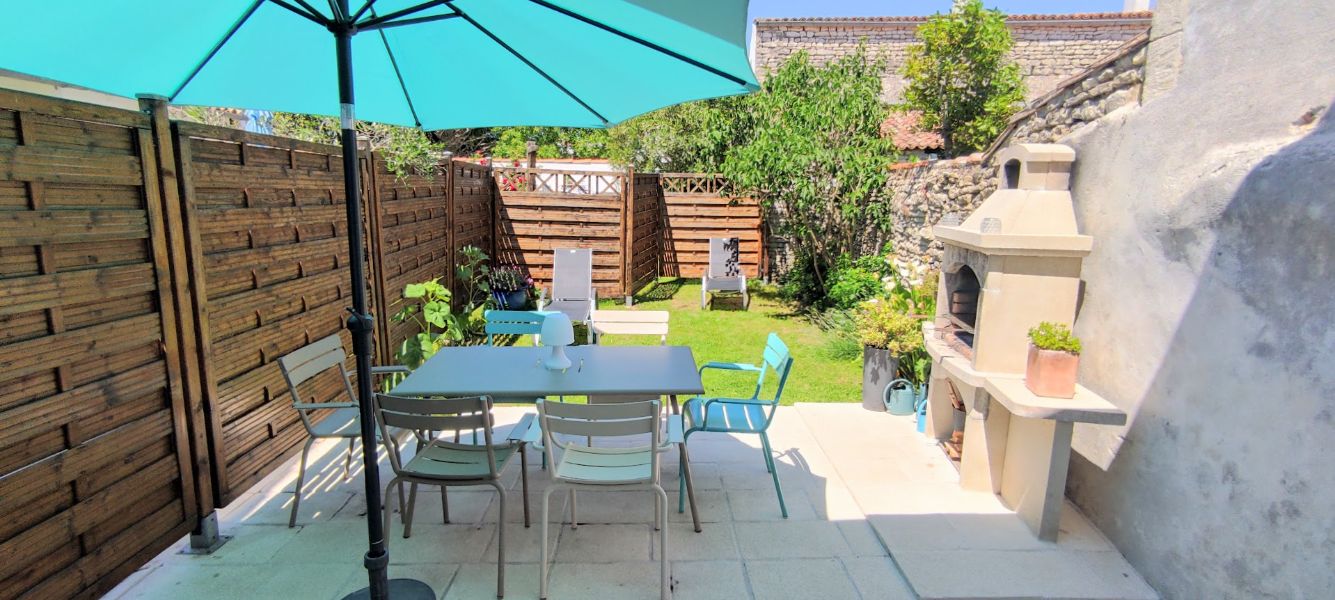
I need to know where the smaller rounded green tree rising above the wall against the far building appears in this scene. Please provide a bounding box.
[904,0,1025,156]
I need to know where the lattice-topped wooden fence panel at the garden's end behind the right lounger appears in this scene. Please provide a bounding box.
[661,172,764,277]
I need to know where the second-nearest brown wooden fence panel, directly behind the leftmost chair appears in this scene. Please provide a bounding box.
[176,123,378,504]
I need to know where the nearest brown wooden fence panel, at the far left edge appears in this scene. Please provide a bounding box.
[0,91,198,599]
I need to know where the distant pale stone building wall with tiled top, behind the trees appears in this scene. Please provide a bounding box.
[752,12,1151,103]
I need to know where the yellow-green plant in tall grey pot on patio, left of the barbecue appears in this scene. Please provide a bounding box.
[857,299,922,412]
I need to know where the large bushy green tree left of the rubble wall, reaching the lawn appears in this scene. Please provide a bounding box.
[722,45,896,296]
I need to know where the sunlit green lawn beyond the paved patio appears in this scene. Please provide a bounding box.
[519,279,862,405]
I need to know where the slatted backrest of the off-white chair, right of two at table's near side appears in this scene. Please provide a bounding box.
[538,400,662,473]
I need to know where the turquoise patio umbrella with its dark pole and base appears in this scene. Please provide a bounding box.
[0,0,757,599]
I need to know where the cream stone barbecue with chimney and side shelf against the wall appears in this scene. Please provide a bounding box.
[924,144,1125,541]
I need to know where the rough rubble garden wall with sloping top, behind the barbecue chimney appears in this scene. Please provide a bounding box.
[881,35,1149,267]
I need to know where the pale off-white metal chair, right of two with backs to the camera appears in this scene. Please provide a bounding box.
[538,401,672,600]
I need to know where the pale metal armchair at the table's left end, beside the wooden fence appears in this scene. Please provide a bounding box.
[278,334,409,527]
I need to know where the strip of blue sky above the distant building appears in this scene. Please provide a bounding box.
[750,0,1142,19]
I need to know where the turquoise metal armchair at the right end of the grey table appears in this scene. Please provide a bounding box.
[677,333,793,518]
